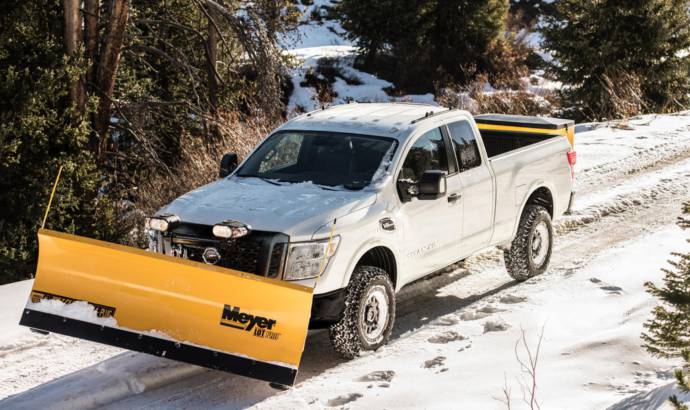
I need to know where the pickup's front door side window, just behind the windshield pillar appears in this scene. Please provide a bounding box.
[400,128,448,182]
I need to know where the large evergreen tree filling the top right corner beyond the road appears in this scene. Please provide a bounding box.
[542,0,690,119]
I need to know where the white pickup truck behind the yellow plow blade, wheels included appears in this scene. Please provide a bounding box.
[149,103,575,357]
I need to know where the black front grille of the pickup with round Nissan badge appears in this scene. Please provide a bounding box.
[170,223,290,278]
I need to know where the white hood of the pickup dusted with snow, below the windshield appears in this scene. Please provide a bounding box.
[158,177,376,240]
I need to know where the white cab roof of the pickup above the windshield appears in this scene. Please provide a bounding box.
[281,103,449,137]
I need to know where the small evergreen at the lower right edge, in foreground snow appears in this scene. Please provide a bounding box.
[642,202,690,410]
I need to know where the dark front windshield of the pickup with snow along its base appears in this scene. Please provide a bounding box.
[236,131,397,190]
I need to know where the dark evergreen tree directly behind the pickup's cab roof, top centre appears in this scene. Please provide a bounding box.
[337,0,523,91]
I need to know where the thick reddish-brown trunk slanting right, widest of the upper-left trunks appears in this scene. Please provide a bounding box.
[94,0,129,162]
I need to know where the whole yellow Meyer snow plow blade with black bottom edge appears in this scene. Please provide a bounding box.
[20,229,312,385]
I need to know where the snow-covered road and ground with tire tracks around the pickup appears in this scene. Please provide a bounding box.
[0,113,690,409]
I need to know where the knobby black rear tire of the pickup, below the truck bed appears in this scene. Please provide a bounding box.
[503,205,553,282]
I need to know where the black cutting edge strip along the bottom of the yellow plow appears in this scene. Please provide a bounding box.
[19,309,297,386]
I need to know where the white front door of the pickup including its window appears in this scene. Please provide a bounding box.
[398,128,462,282]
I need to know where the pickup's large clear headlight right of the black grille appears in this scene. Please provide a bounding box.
[283,235,340,280]
